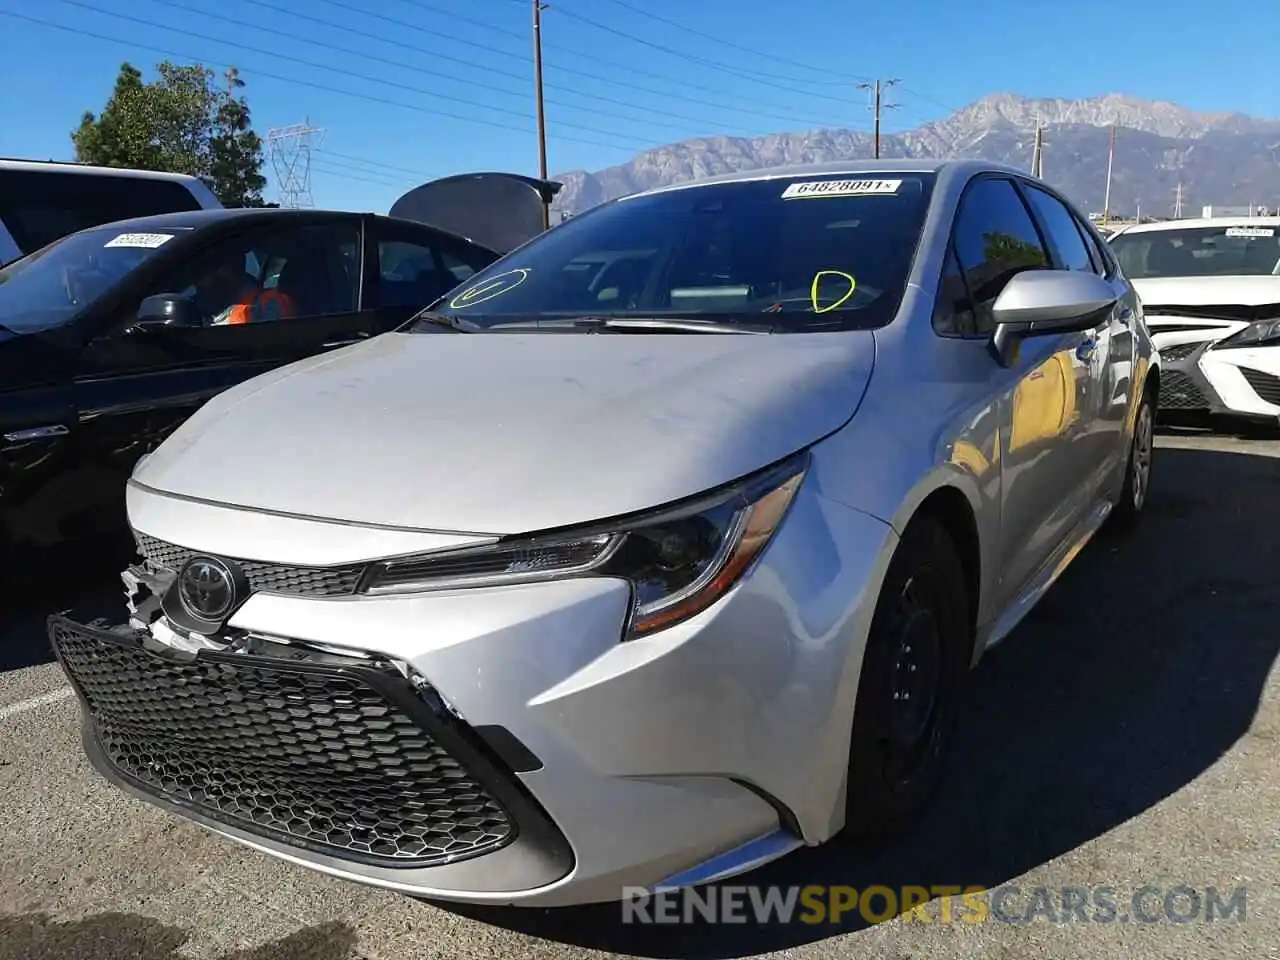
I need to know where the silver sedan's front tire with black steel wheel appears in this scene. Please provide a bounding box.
[841,515,973,846]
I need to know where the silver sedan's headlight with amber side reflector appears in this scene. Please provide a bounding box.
[362,454,808,636]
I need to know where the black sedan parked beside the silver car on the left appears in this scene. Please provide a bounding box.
[0,209,498,556]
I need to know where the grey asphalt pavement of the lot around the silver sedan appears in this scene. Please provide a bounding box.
[0,435,1280,960]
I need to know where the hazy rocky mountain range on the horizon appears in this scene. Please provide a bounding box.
[553,93,1280,216]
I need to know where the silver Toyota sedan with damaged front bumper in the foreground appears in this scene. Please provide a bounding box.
[50,161,1158,905]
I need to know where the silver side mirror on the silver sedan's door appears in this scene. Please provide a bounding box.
[991,270,1117,366]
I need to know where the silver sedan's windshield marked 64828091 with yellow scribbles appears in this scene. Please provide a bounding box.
[411,174,933,332]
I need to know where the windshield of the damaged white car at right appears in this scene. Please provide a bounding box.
[1111,224,1280,280]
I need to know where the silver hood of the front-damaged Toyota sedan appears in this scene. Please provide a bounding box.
[134,332,876,534]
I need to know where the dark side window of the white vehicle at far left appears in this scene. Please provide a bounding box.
[0,170,200,253]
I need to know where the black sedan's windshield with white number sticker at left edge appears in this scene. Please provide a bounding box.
[0,229,185,333]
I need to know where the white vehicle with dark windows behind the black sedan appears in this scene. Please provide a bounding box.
[0,159,221,265]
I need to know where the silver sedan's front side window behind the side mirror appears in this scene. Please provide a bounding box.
[952,178,1050,333]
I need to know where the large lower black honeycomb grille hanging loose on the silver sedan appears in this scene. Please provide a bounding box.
[50,618,516,867]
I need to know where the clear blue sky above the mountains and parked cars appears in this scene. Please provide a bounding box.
[0,0,1280,212]
